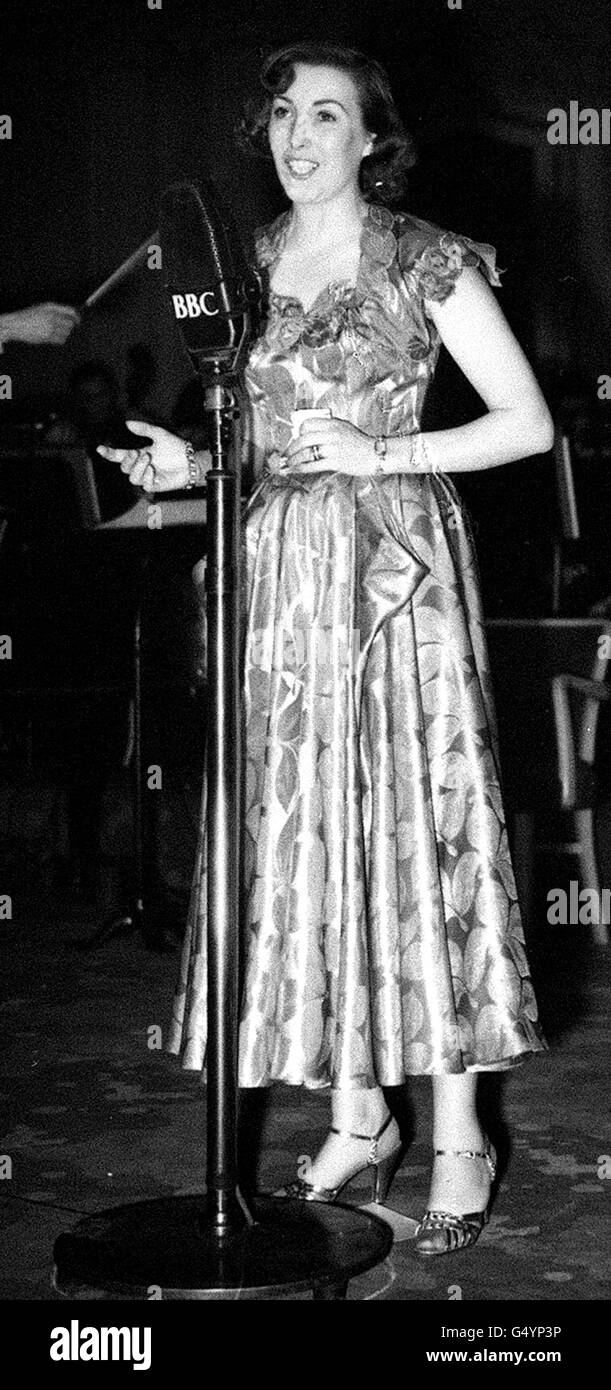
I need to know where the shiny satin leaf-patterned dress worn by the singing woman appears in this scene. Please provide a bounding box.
[169,206,546,1088]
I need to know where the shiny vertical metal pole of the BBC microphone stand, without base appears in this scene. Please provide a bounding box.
[204,363,245,1233]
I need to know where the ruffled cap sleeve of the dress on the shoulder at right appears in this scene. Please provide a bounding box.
[399,218,501,304]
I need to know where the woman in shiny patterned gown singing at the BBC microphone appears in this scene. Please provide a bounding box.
[102,44,553,1255]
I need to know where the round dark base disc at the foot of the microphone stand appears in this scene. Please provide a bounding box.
[54,1195,393,1300]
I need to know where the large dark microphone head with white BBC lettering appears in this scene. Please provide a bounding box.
[160,179,261,381]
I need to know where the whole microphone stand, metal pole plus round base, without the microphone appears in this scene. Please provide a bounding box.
[54,273,393,1301]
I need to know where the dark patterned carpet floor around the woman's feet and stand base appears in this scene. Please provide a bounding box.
[0,867,611,1301]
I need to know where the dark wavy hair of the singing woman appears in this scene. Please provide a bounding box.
[236,43,417,204]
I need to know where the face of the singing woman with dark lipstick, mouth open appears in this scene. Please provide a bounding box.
[268,63,374,204]
